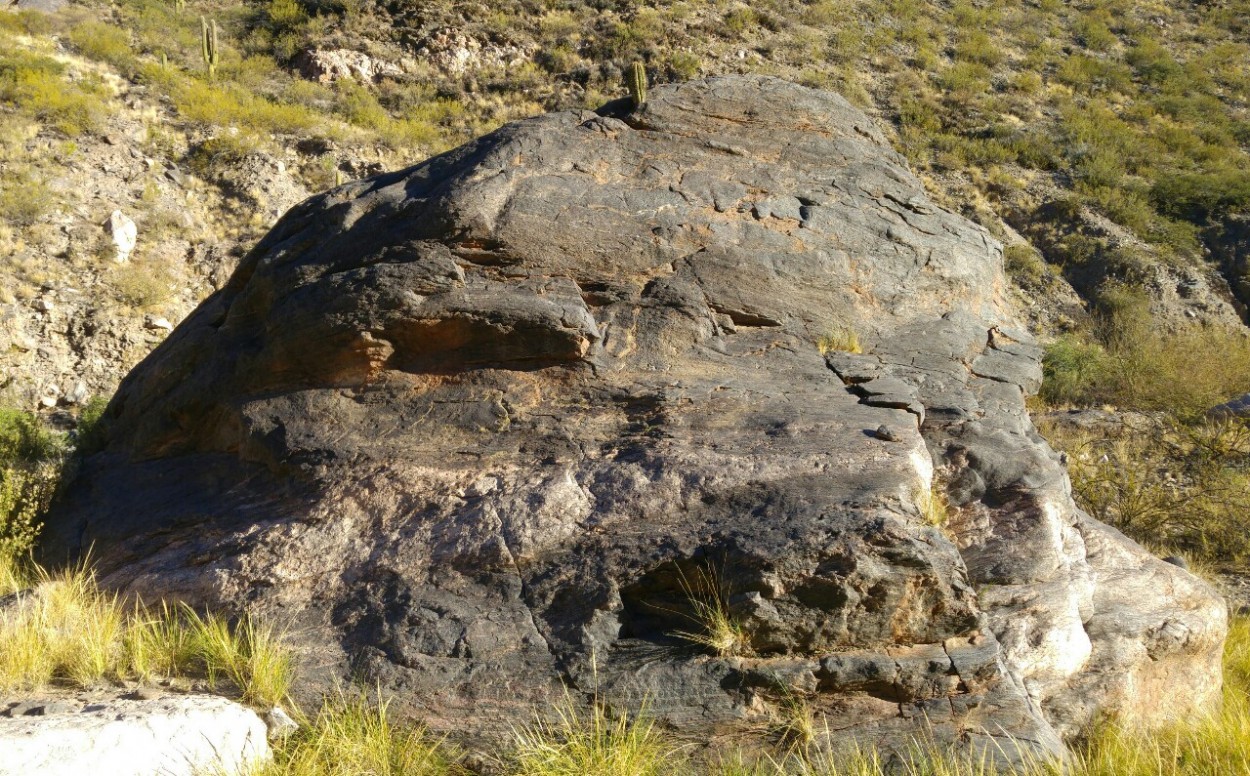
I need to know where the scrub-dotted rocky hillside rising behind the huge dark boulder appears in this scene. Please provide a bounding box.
[0,0,1250,417]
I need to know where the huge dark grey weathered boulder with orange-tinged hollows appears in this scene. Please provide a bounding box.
[49,77,1225,752]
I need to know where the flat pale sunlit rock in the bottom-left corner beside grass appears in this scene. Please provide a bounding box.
[0,695,270,776]
